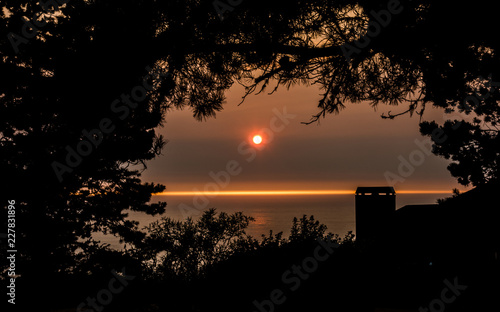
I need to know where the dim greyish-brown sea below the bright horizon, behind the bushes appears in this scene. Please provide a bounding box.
[95,193,451,249]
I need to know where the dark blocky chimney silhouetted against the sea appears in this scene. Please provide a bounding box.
[355,186,396,241]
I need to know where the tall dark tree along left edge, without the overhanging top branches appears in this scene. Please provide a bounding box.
[0,1,167,294]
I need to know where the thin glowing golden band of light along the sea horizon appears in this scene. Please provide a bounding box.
[153,190,452,196]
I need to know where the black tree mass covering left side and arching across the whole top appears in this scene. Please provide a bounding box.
[0,0,500,294]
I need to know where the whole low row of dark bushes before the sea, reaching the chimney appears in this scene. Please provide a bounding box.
[136,208,353,280]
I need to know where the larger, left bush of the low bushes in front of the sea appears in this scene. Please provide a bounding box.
[138,208,254,279]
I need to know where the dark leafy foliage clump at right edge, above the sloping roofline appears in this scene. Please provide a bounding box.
[420,76,500,186]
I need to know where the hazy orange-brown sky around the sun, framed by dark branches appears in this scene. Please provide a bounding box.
[142,85,464,193]
